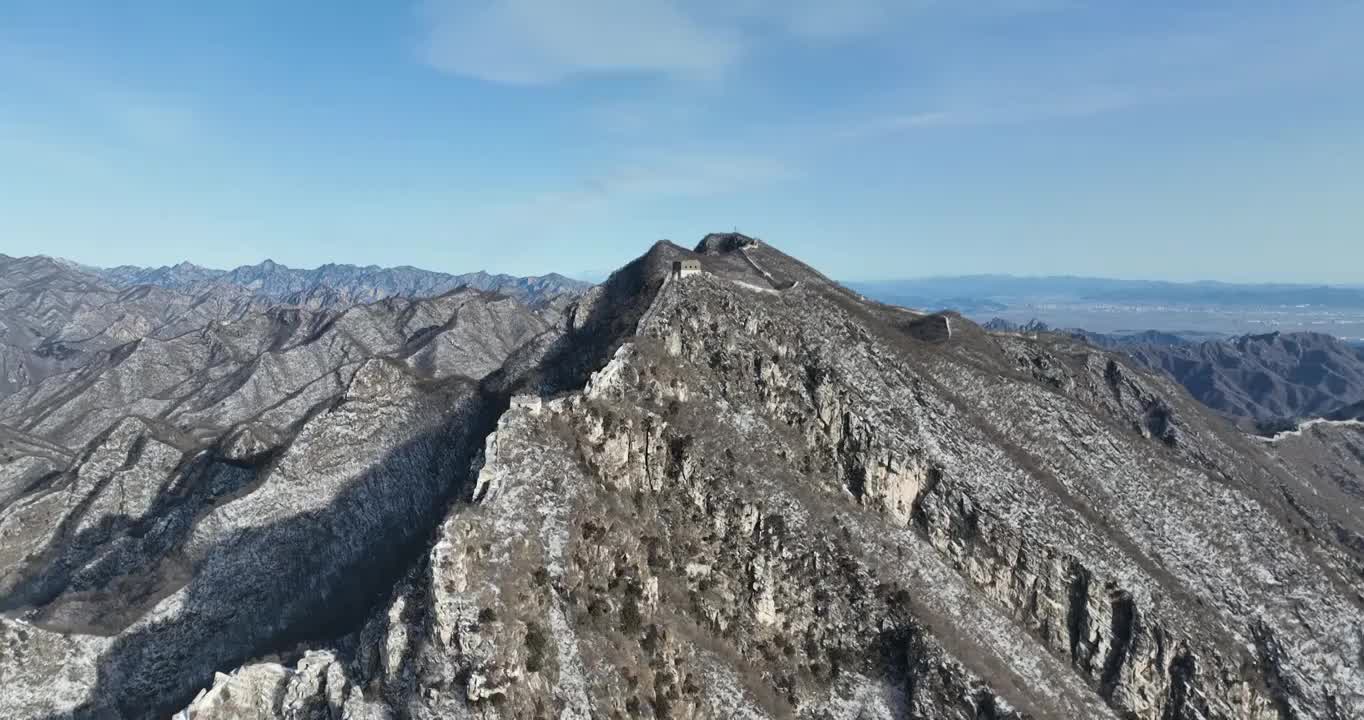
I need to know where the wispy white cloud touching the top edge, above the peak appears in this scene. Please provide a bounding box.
[419,0,1071,85]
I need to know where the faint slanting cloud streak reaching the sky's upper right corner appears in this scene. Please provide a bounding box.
[835,3,1364,139]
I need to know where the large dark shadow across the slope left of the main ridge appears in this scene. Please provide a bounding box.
[75,379,496,720]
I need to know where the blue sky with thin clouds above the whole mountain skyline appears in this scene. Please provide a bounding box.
[0,0,1364,282]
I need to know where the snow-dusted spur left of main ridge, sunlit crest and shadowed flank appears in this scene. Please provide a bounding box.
[4,361,499,719]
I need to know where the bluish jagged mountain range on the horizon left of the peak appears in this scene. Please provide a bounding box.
[100,260,591,310]
